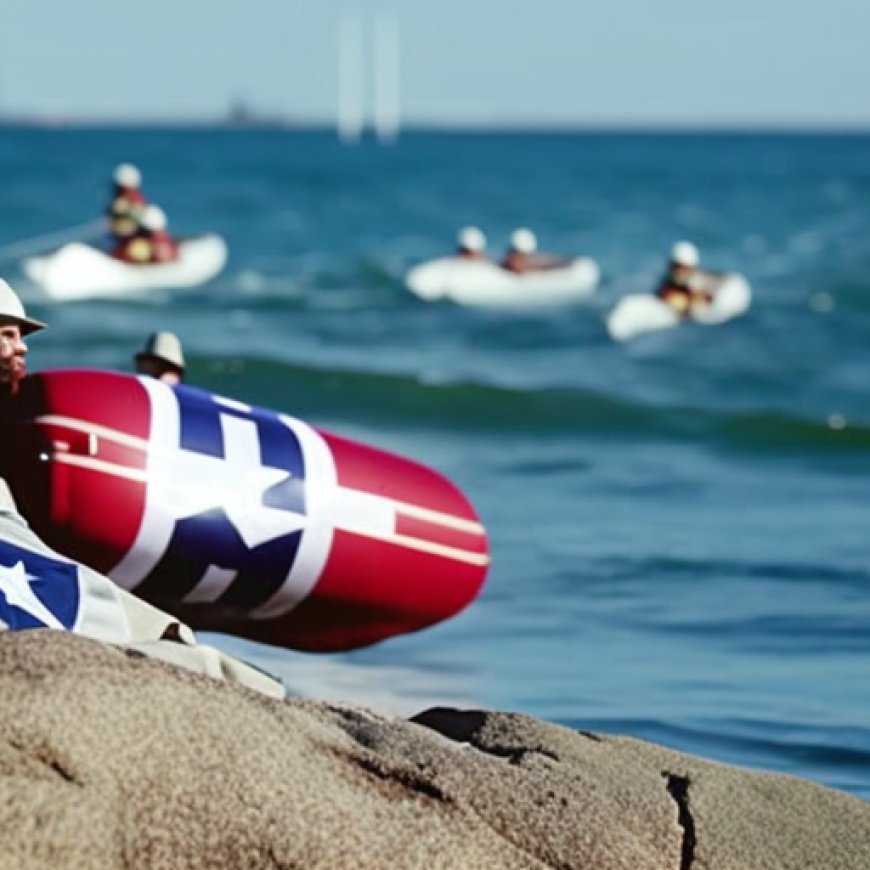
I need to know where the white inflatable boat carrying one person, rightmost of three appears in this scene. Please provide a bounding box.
[606,272,752,341]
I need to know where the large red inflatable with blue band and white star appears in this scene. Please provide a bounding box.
[0,370,489,651]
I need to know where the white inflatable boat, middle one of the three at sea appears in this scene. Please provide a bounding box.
[405,257,598,308]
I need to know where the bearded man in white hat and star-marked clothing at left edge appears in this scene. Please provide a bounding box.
[0,278,286,698]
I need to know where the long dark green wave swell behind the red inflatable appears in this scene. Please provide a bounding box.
[192,356,870,456]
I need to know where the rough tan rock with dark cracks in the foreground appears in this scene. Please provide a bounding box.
[0,630,870,870]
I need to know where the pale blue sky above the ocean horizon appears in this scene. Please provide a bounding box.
[0,0,870,128]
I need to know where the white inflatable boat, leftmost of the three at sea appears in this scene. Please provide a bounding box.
[21,234,227,301]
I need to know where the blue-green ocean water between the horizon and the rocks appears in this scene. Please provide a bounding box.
[0,128,870,798]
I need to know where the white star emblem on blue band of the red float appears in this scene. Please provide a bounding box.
[154,414,307,549]
